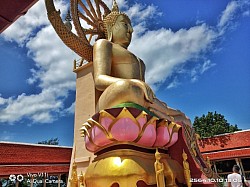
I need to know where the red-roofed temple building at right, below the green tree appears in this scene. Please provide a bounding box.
[199,130,250,180]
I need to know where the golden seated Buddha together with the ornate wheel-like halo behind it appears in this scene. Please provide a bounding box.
[45,0,191,125]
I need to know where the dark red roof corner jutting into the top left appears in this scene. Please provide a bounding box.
[0,0,38,33]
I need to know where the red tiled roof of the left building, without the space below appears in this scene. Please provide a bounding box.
[0,141,72,176]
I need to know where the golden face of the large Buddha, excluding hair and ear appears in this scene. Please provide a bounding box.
[112,15,133,48]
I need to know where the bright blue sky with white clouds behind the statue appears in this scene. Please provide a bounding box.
[0,0,250,146]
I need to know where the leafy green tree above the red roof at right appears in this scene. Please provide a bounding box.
[193,111,241,138]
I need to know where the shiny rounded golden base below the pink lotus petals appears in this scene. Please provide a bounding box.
[85,149,184,187]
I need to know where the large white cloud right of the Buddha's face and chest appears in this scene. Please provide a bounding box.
[130,24,217,85]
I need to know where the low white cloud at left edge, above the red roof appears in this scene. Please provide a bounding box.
[0,89,63,123]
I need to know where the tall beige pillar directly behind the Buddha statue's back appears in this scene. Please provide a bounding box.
[68,63,97,182]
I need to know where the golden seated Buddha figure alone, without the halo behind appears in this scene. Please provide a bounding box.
[93,1,191,125]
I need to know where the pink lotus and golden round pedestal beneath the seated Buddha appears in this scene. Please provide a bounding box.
[69,107,219,187]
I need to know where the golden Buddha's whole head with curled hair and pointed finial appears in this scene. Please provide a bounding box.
[104,0,133,48]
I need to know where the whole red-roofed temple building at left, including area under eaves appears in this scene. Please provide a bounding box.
[0,141,72,186]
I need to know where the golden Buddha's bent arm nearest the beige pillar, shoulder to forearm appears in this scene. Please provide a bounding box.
[93,40,122,91]
